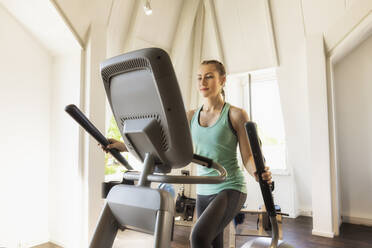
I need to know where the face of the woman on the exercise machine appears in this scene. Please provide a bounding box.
[198,64,225,97]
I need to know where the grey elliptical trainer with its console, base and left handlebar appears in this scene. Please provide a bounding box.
[65,48,226,248]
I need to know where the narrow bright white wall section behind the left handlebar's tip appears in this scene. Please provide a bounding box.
[48,50,82,247]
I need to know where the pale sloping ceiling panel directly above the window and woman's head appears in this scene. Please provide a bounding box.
[214,0,277,73]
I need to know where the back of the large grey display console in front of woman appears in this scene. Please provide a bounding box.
[101,48,193,173]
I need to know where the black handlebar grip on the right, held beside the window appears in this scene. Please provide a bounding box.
[245,121,276,217]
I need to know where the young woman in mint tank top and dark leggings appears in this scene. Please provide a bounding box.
[106,60,271,248]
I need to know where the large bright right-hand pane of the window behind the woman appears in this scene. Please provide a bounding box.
[251,80,286,169]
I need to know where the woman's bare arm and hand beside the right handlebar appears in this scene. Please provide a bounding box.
[230,107,272,183]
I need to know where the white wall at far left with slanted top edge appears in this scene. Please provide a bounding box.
[0,5,52,247]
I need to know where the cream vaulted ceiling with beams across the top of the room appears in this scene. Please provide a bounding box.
[0,0,357,69]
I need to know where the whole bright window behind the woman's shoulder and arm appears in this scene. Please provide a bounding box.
[226,69,286,172]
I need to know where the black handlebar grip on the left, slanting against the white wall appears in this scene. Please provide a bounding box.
[65,104,133,170]
